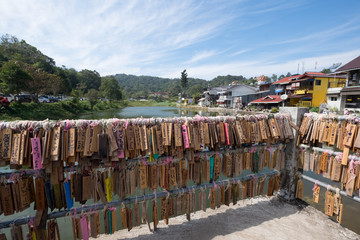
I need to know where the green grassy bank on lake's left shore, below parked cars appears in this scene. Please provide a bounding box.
[0,101,127,120]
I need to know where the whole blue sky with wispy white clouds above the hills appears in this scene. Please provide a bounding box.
[0,0,360,80]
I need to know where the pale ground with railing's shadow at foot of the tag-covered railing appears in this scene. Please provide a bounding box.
[93,197,360,240]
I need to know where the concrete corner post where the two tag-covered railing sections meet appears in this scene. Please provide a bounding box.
[279,107,309,200]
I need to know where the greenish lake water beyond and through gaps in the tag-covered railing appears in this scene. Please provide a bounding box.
[0,107,360,239]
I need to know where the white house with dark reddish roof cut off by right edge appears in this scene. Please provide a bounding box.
[334,56,360,112]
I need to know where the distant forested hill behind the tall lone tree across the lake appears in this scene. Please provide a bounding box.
[114,74,250,98]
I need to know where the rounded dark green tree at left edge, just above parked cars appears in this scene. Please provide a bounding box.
[0,61,32,94]
